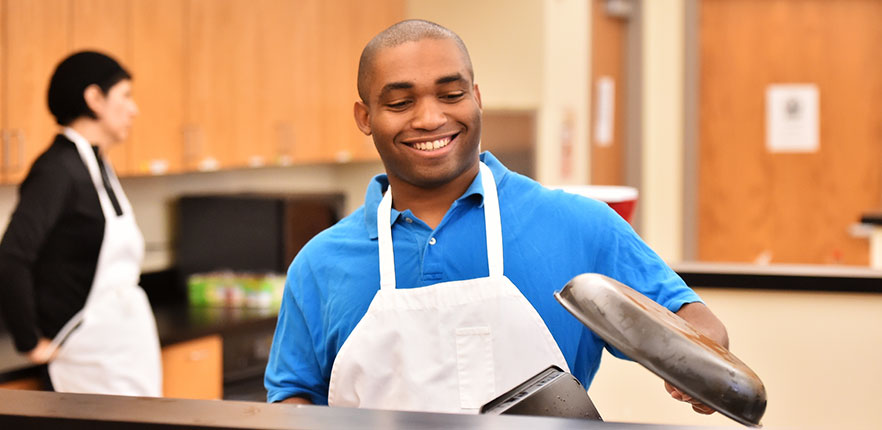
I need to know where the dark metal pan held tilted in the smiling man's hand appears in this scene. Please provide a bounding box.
[554,273,766,427]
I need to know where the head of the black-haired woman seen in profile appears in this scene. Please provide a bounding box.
[47,51,137,141]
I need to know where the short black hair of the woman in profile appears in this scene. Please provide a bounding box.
[48,51,132,125]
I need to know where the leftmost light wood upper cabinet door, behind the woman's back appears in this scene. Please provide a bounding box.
[0,0,70,183]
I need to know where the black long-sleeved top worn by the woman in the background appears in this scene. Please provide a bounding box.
[0,134,121,352]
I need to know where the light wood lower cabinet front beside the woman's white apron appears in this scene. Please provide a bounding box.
[162,335,223,399]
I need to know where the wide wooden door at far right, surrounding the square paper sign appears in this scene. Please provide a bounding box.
[698,0,882,265]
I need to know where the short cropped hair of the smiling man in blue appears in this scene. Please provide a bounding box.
[358,19,475,103]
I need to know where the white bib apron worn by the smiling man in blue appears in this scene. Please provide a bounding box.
[328,163,569,413]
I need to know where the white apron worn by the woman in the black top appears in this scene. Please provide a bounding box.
[49,129,162,397]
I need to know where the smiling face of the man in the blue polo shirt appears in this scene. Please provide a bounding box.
[355,39,481,189]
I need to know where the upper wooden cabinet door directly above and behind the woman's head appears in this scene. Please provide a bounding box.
[70,0,137,175]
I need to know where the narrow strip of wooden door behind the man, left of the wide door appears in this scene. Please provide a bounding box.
[588,0,628,185]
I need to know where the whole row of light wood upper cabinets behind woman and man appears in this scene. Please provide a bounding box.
[0,0,404,183]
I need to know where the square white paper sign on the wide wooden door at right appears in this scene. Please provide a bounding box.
[766,84,819,152]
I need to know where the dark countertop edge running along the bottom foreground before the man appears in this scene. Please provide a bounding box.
[0,389,744,430]
